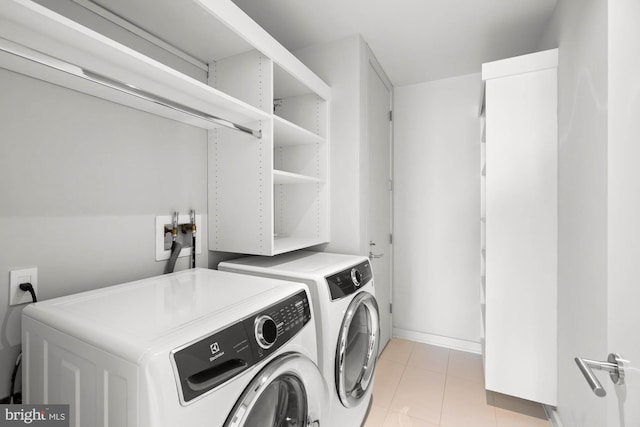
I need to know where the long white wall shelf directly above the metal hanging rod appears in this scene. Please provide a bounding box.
[0,0,269,129]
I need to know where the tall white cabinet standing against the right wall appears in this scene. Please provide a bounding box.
[481,49,558,405]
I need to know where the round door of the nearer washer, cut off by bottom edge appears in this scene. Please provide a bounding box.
[224,353,327,427]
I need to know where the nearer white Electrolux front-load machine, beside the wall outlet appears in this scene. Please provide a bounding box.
[22,269,329,427]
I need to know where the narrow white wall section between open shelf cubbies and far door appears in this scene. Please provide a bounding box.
[293,35,369,254]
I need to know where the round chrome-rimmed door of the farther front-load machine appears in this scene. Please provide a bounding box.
[336,292,380,408]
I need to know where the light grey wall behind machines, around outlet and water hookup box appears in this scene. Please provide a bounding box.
[0,70,207,397]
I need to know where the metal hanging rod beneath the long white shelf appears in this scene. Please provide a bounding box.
[0,38,262,138]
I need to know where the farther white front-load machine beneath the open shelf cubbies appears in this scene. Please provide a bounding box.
[218,251,380,427]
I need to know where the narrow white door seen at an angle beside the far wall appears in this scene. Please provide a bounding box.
[367,58,392,351]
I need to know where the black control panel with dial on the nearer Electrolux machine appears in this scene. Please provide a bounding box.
[171,291,311,405]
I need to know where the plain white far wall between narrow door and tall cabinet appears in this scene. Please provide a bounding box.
[393,73,482,351]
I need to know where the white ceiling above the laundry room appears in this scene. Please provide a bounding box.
[233,0,557,86]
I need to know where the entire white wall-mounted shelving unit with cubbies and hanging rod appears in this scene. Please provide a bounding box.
[0,0,331,255]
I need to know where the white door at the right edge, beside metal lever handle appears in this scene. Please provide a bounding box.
[596,0,640,427]
